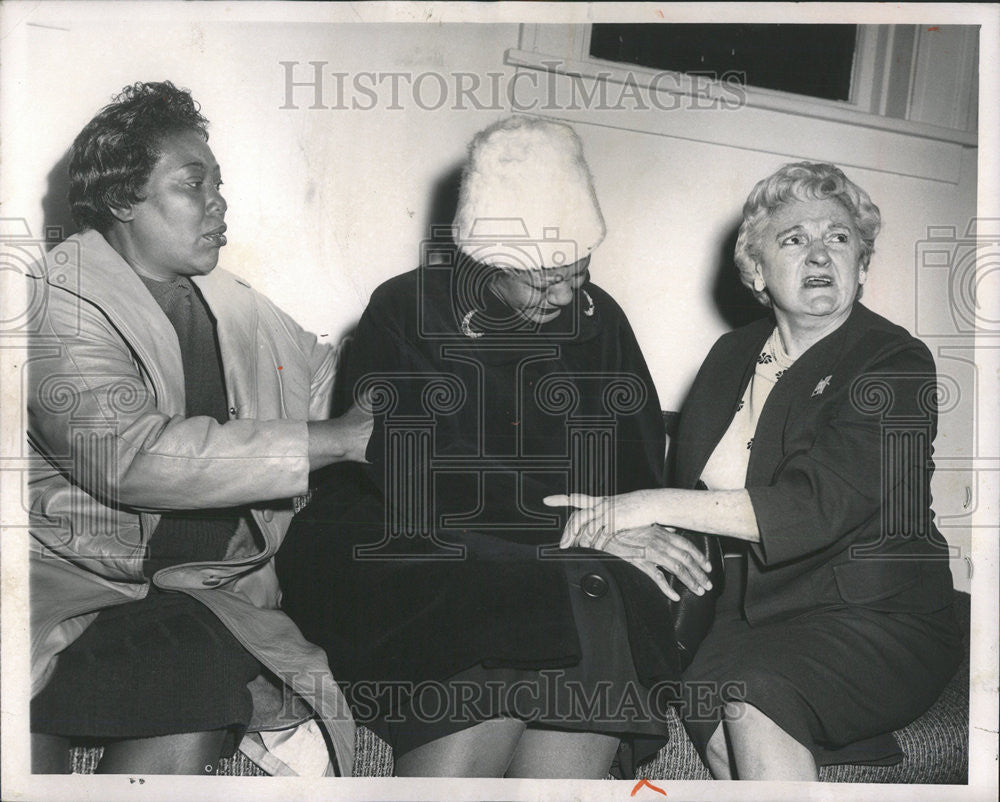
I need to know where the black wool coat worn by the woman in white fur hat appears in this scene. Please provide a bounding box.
[278,260,704,700]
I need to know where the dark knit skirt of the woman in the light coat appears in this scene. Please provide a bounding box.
[31,588,261,754]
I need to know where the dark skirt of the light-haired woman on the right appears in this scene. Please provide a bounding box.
[682,557,962,766]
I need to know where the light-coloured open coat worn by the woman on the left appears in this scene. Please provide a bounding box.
[28,231,354,775]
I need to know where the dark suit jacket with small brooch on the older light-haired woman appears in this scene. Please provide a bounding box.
[675,304,952,624]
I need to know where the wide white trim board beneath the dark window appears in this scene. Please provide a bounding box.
[504,48,978,184]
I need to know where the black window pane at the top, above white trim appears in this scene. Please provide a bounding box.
[590,23,857,100]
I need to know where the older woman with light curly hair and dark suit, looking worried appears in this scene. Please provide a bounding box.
[548,163,960,780]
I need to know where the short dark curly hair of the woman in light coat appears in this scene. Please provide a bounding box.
[69,81,208,234]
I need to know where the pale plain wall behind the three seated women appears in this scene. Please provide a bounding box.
[2,9,977,587]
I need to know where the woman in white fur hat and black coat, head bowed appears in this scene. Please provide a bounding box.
[278,118,720,778]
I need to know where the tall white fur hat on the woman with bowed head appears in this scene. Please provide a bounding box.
[455,117,605,270]
